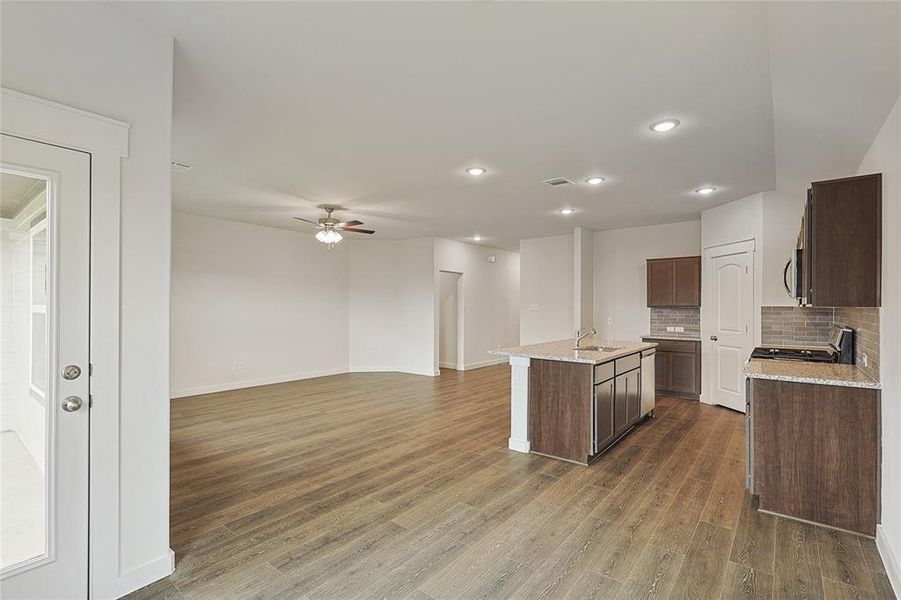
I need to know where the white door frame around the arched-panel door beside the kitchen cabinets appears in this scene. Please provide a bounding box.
[700,238,761,404]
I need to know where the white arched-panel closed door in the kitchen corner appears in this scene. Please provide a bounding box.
[709,249,754,412]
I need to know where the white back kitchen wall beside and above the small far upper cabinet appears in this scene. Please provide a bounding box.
[594,221,701,340]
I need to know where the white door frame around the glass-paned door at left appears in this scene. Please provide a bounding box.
[0,88,175,598]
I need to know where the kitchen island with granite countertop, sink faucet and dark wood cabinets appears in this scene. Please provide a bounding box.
[491,338,657,465]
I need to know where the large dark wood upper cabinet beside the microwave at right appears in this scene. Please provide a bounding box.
[800,173,882,306]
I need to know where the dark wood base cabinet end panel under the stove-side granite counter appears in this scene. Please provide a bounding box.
[750,379,879,536]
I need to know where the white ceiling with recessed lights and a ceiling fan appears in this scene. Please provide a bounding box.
[128,2,901,248]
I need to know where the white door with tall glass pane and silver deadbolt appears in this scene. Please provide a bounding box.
[0,135,90,599]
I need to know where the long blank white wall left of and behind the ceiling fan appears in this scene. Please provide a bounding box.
[170,212,349,397]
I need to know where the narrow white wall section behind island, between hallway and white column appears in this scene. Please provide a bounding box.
[519,235,575,345]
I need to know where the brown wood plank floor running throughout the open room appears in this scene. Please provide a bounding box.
[130,365,894,600]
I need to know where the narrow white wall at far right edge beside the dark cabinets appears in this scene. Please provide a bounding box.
[858,92,901,594]
